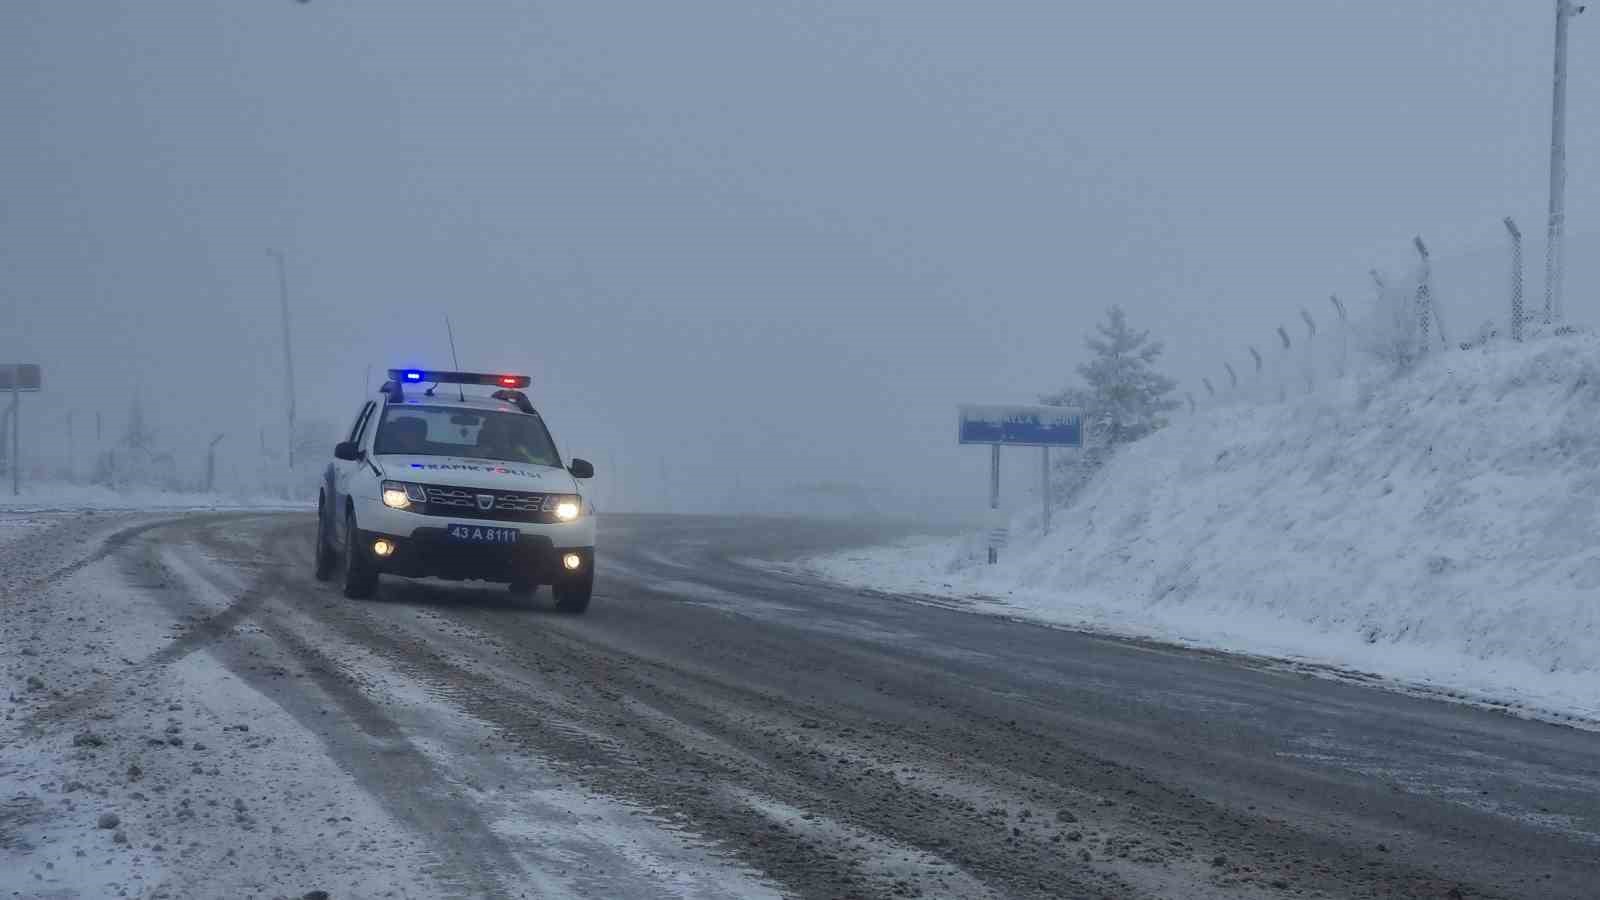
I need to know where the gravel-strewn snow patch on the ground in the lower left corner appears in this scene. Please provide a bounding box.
[0,516,443,898]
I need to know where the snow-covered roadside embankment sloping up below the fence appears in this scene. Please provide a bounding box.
[780,335,1600,722]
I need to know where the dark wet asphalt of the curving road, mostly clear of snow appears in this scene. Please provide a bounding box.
[31,514,1600,898]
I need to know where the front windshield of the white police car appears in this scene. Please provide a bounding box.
[373,405,562,466]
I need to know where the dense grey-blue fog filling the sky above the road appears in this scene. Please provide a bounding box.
[0,0,1600,516]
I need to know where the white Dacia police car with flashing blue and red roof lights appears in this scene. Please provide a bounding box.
[317,368,595,613]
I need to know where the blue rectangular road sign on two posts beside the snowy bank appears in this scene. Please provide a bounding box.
[955,404,1083,565]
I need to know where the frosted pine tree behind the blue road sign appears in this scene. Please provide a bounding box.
[1040,306,1181,498]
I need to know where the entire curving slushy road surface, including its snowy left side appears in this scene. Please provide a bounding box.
[0,512,1600,898]
